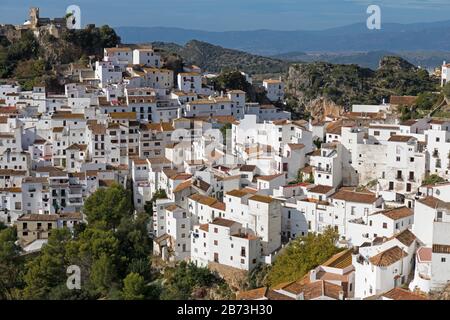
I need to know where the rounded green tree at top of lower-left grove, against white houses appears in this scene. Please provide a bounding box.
[83,184,133,230]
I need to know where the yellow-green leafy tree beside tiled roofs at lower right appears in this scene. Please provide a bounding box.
[267,229,340,286]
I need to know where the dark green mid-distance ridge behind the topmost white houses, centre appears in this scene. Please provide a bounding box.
[152,40,290,74]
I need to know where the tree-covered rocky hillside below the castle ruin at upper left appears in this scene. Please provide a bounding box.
[0,26,120,91]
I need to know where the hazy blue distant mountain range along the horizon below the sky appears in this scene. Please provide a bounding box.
[116,21,450,55]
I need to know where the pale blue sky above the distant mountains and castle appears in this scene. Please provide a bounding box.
[0,0,450,31]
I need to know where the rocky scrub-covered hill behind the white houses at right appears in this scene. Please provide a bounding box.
[286,56,437,117]
